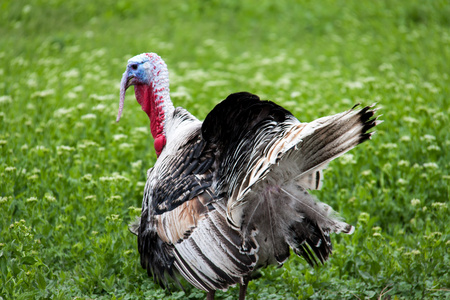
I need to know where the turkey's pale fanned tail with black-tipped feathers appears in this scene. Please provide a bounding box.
[235,105,381,265]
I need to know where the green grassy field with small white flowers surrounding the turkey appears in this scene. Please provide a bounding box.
[0,0,450,299]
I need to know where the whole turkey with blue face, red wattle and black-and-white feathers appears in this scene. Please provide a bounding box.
[117,53,380,300]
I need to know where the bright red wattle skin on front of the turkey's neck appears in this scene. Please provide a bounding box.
[134,85,166,157]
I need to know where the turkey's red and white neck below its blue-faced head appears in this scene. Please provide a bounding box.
[134,68,174,156]
